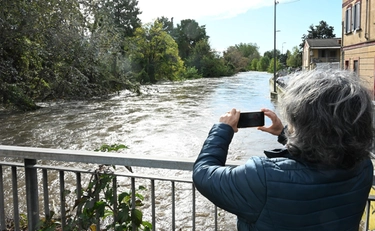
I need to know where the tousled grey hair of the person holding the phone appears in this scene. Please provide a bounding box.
[281,70,374,168]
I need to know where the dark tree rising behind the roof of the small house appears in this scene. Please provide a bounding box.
[299,20,336,50]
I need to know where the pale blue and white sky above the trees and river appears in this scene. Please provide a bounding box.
[138,0,342,54]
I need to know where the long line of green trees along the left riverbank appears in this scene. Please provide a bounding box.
[0,0,324,110]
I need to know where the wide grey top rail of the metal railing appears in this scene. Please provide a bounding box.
[0,145,241,170]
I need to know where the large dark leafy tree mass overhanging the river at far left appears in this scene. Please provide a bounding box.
[0,0,141,110]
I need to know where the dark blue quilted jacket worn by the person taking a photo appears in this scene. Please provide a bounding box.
[193,124,373,231]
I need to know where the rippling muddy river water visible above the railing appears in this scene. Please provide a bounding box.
[0,72,279,160]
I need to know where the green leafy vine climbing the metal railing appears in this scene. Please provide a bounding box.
[39,145,152,231]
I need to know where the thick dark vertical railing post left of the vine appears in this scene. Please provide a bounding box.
[25,159,39,231]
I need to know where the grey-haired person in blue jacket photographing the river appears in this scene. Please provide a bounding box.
[193,71,373,231]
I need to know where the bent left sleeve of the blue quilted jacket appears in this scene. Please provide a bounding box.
[193,124,266,223]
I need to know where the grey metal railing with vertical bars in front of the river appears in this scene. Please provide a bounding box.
[0,145,375,231]
